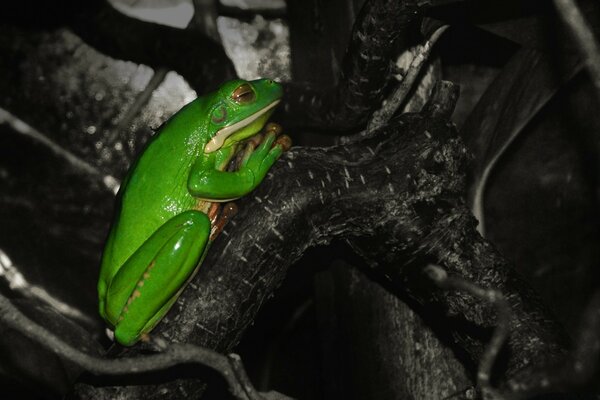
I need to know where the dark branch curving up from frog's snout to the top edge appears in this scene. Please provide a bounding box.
[283,0,436,132]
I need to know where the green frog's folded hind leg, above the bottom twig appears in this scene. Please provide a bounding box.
[105,210,210,346]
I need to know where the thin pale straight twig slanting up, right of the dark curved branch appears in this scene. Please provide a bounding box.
[366,25,448,136]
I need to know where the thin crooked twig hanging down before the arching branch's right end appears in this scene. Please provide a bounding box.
[425,265,511,399]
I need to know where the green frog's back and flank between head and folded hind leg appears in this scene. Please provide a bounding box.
[102,101,209,276]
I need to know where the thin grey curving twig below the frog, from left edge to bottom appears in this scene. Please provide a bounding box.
[0,295,278,400]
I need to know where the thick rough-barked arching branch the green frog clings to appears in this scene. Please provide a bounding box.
[70,95,564,399]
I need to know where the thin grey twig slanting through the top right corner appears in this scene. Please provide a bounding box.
[554,0,600,99]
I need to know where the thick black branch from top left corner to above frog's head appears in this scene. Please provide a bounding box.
[0,0,236,94]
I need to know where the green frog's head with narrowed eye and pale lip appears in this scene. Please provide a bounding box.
[204,79,283,153]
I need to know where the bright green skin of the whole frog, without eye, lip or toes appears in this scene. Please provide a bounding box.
[98,79,283,346]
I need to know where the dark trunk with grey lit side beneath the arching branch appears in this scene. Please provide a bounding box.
[316,263,473,400]
